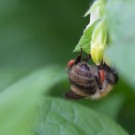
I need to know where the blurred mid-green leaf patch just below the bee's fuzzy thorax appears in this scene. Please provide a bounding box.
[79,94,124,120]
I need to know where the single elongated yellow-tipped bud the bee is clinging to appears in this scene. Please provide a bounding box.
[91,19,107,65]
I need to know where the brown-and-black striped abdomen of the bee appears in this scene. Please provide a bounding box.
[69,63,97,95]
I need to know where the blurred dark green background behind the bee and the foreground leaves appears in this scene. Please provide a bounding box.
[0,0,135,133]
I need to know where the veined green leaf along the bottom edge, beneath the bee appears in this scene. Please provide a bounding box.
[36,98,128,135]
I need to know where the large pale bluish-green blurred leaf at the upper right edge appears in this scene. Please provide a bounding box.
[106,0,135,87]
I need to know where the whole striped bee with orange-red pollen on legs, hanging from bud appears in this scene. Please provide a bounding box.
[65,50,118,99]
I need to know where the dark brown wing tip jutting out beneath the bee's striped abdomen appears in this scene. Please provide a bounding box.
[65,91,84,99]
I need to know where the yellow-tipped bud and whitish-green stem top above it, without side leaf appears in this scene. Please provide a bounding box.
[85,0,108,65]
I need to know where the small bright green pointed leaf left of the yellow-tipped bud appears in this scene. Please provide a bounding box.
[74,20,99,54]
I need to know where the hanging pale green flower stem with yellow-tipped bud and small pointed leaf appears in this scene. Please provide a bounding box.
[76,0,109,65]
